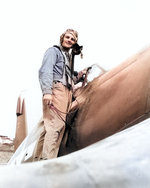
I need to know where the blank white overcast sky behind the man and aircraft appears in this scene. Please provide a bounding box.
[0,0,150,138]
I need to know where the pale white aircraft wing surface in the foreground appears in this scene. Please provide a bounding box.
[0,119,150,188]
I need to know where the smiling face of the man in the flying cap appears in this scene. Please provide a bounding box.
[62,33,75,49]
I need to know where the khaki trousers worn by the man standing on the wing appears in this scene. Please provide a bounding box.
[34,82,72,160]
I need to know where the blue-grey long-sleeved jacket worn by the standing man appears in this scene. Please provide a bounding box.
[39,47,69,95]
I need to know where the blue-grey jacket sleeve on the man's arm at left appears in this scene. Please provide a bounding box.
[39,48,57,95]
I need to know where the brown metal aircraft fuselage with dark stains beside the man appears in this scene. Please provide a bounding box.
[59,47,150,156]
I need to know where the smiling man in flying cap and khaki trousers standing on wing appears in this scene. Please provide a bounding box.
[35,29,83,160]
